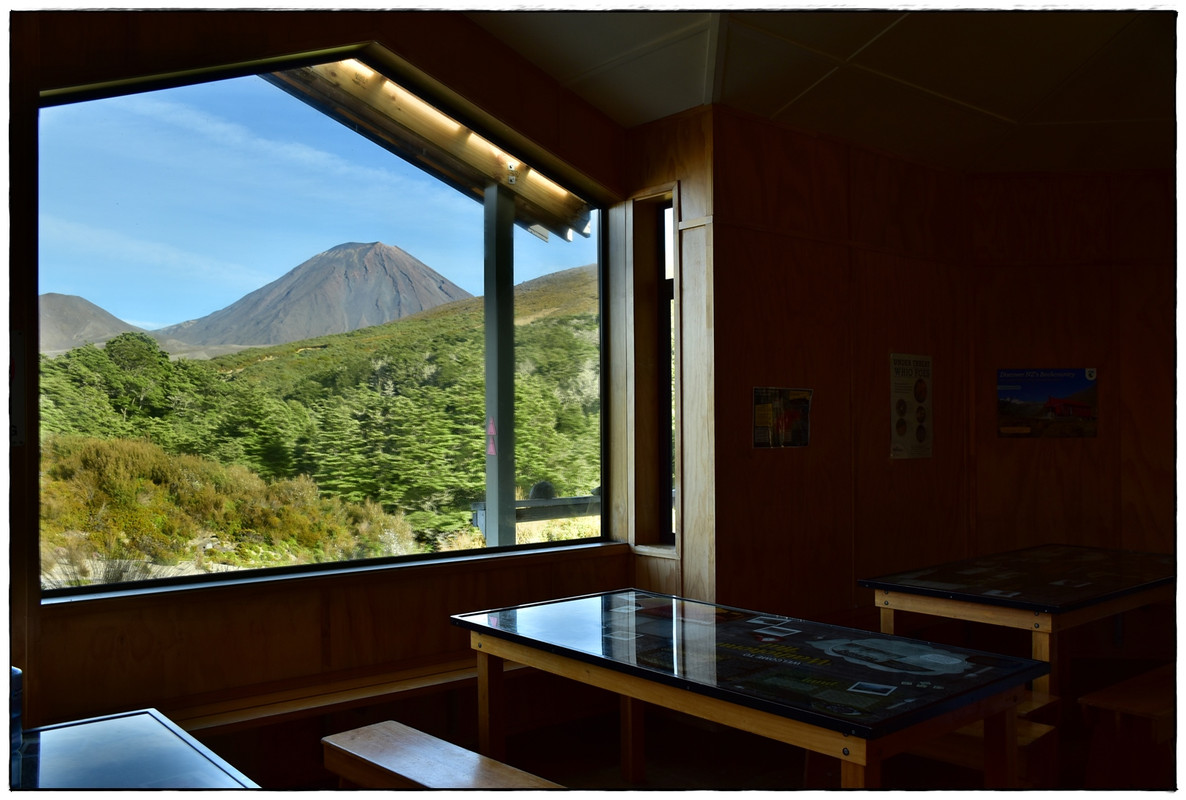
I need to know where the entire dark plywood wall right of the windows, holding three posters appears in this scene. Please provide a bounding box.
[664,109,1174,619]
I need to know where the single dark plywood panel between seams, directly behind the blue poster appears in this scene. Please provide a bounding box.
[971,186,1123,553]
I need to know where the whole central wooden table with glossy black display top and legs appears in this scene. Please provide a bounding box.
[452,589,1048,788]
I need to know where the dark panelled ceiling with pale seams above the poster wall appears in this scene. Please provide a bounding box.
[468,11,1177,171]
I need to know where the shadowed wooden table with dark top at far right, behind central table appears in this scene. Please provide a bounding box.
[857,544,1175,696]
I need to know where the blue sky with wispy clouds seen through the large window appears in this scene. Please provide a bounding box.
[39,71,597,328]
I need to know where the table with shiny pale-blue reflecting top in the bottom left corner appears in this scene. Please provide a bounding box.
[14,709,257,789]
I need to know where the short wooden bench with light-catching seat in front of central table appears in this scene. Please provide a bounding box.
[321,721,563,789]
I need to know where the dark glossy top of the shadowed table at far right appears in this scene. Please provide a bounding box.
[857,544,1175,613]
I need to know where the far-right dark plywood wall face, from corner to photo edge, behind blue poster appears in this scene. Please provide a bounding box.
[969,173,1177,552]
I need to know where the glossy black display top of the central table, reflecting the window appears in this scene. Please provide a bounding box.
[452,589,1047,738]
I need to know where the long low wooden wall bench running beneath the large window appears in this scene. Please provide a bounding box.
[169,658,518,734]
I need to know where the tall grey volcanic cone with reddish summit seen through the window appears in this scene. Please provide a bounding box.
[153,242,472,346]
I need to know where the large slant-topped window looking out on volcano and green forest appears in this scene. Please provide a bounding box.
[38,48,601,591]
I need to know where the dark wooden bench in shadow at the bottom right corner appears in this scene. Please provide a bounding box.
[1079,664,1177,789]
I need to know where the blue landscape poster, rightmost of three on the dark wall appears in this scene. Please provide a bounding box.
[996,367,1098,439]
